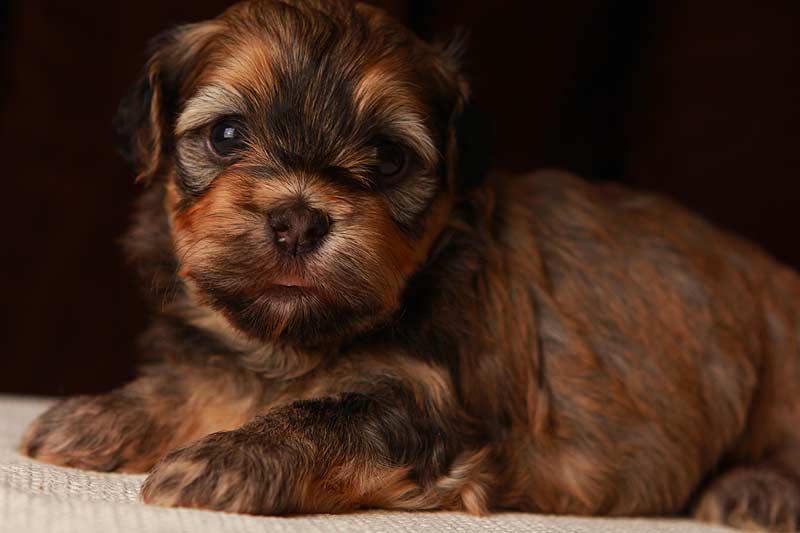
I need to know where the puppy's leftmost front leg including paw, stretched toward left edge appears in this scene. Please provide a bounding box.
[20,366,252,473]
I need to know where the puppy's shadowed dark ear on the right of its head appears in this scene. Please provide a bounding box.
[434,31,489,190]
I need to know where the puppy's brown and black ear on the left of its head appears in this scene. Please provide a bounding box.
[114,21,219,183]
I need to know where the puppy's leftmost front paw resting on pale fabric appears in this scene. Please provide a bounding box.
[19,393,161,472]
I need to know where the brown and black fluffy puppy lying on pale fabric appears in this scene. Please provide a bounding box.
[17,0,800,530]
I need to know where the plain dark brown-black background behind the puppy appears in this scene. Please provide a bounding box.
[0,0,800,394]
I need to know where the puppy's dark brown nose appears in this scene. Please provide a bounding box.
[267,204,330,256]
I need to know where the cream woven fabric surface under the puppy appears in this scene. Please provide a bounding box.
[0,396,731,533]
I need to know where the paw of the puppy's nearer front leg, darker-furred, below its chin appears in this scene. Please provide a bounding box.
[142,430,279,514]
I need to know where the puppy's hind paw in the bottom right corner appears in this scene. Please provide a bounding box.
[694,468,800,531]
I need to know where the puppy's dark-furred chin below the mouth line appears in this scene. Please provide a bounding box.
[192,274,391,349]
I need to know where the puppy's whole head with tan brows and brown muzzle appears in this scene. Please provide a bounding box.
[121,1,466,344]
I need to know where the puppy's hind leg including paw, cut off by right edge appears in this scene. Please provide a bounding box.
[694,270,800,531]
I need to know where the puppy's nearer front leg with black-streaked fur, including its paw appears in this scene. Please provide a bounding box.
[142,387,490,514]
